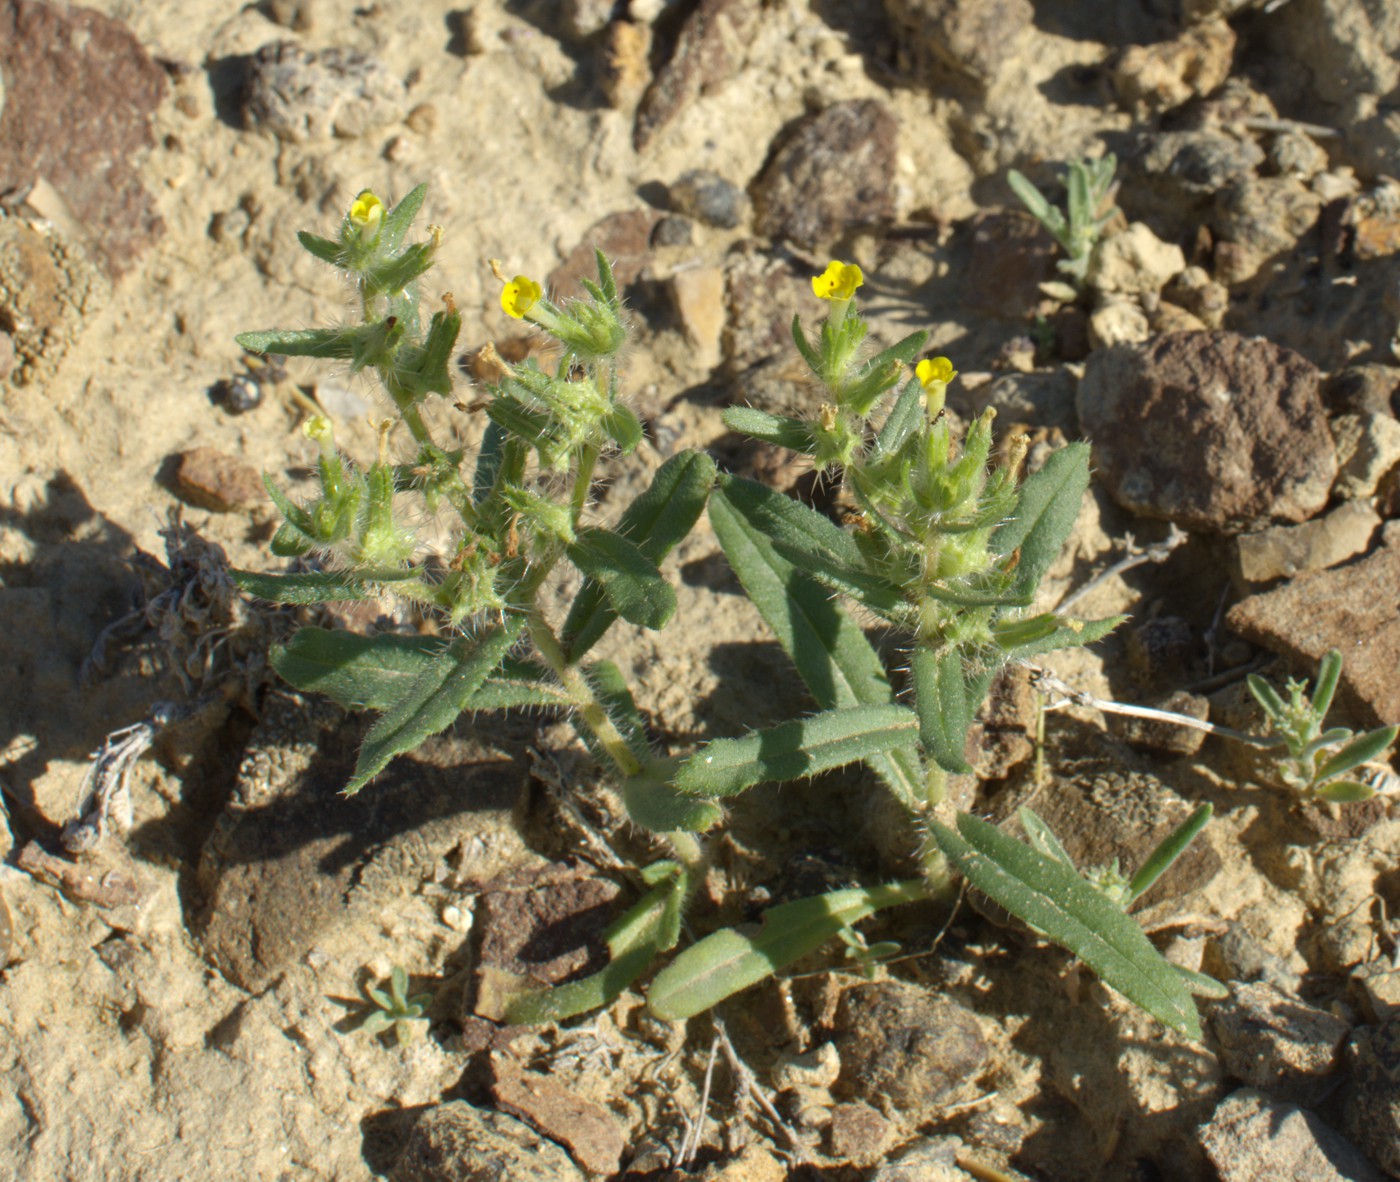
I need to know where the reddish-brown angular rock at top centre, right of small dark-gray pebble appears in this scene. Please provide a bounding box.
[752,98,899,249]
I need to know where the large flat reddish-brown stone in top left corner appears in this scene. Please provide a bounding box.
[0,0,165,279]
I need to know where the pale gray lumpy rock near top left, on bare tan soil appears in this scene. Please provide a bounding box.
[244,41,407,144]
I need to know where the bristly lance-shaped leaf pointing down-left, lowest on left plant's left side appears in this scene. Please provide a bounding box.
[344,619,521,795]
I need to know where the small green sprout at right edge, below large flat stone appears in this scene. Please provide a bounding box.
[1249,648,1400,804]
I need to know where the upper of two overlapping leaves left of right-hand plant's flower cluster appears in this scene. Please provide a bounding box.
[720,476,906,618]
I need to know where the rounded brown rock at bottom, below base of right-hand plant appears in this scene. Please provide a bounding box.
[834,980,990,1123]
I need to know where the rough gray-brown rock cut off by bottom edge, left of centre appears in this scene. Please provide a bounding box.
[389,1099,587,1182]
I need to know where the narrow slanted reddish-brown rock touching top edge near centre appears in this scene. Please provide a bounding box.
[631,0,759,151]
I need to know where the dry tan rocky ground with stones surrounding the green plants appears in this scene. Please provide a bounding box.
[0,0,1400,1182]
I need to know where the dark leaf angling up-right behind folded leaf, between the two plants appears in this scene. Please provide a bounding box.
[563,451,715,662]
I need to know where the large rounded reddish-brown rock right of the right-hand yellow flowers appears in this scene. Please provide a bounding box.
[1077,332,1337,534]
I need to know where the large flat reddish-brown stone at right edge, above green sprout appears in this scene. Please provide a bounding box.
[1225,522,1400,727]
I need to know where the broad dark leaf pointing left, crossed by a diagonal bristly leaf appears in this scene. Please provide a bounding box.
[272,627,568,710]
